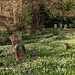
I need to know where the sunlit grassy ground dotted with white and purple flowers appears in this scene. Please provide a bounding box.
[0,28,75,75]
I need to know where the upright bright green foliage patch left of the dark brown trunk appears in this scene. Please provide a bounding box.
[22,4,33,25]
